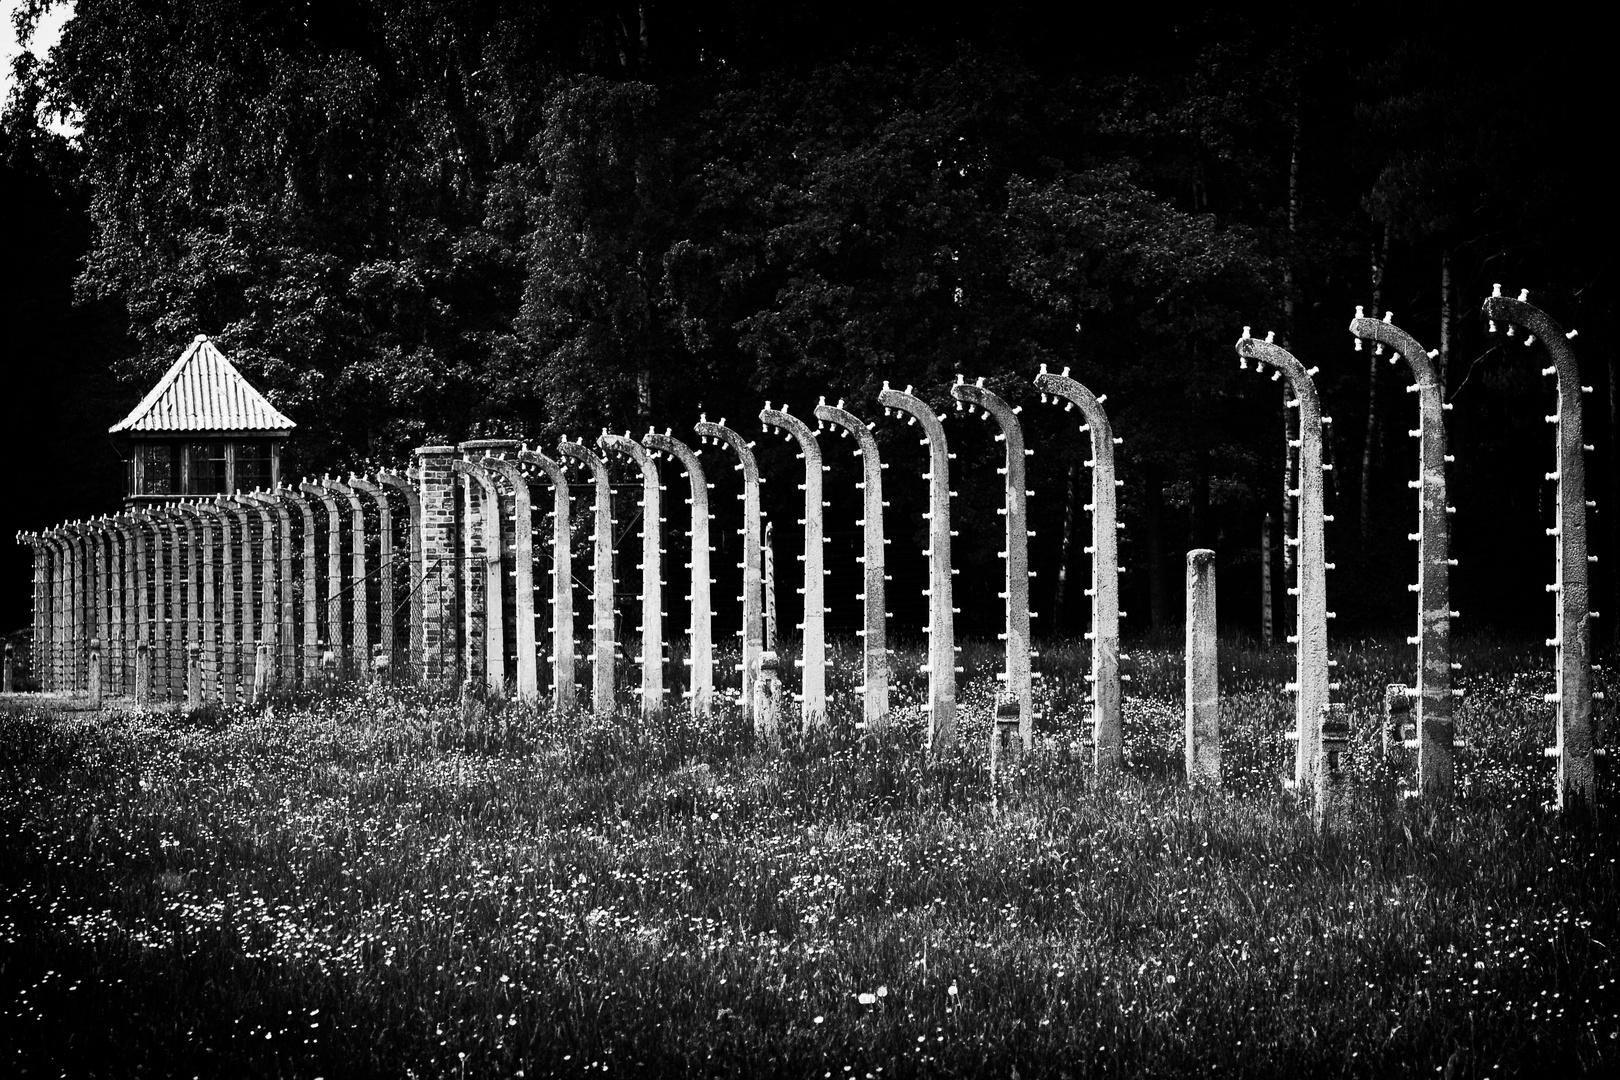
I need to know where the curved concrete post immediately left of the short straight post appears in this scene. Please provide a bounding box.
[1035,372,1126,774]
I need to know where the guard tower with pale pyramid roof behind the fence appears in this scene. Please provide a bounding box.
[109,334,296,507]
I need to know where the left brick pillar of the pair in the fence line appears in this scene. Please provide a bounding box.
[416,447,462,683]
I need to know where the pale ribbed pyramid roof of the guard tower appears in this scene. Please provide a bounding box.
[107,334,296,432]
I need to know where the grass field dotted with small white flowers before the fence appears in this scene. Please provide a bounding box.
[0,643,1620,1080]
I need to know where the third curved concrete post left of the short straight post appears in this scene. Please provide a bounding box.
[878,382,956,756]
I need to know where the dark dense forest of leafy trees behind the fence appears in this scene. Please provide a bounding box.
[0,0,1620,638]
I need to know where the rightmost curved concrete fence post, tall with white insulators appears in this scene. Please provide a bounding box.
[1484,285,1597,810]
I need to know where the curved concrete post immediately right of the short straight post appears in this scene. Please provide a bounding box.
[1238,327,1330,797]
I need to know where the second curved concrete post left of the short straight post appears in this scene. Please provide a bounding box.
[951,376,1035,750]
